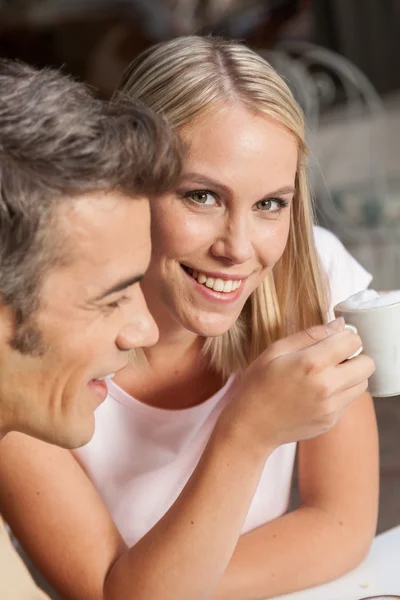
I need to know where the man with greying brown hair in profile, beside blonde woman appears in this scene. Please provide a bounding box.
[0,61,181,600]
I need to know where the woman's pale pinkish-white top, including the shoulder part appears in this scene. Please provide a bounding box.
[73,227,371,546]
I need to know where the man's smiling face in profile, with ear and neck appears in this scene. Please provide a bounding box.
[0,193,158,448]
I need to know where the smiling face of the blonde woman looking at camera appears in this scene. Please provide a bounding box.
[143,104,298,336]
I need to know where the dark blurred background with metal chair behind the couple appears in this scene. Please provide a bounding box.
[0,0,400,596]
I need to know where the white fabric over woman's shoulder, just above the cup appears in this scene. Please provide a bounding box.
[314,226,372,308]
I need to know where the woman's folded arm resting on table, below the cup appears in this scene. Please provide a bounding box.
[213,394,379,600]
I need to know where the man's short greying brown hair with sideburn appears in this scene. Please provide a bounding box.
[0,60,181,332]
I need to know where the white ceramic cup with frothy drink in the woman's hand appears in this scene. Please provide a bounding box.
[334,292,400,398]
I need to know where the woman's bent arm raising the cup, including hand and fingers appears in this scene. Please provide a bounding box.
[0,322,373,600]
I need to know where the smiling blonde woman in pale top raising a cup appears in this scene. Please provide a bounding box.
[0,37,378,600]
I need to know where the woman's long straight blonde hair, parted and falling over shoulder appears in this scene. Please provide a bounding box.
[114,36,327,376]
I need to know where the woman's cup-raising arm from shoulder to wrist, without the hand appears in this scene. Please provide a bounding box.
[0,432,272,600]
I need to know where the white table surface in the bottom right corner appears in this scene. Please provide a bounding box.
[277,526,400,600]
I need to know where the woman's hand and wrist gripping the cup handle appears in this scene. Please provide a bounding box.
[220,319,375,450]
